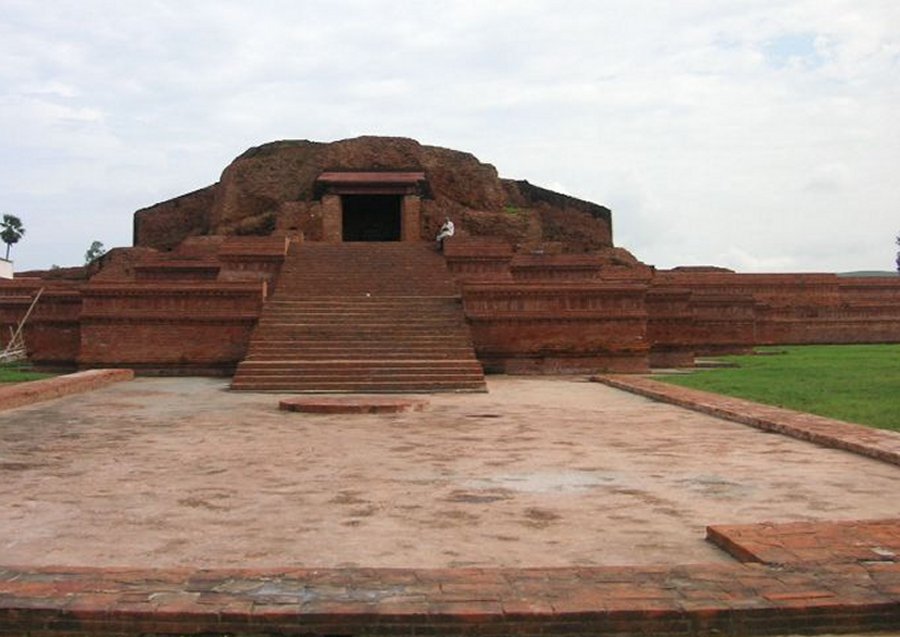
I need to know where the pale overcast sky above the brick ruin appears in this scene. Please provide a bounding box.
[0,0,900,272]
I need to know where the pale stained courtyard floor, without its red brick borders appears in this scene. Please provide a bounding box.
[0,377,900,568]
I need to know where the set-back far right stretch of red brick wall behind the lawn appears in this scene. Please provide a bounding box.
[648,269,900,354]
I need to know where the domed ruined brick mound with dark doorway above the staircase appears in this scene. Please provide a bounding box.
[134,137,628,259]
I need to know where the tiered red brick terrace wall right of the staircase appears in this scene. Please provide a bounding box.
[458,246,900,372]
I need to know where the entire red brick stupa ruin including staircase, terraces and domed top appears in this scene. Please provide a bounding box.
[0,137,900,391]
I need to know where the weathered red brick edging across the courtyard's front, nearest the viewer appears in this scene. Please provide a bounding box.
[0,564,900,636]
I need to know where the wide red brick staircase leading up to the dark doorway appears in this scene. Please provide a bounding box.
[231,242,485,392]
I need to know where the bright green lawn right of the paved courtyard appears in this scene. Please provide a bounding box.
[657,345,900,431]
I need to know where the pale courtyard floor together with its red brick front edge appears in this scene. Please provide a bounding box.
[0,377,900,635]
